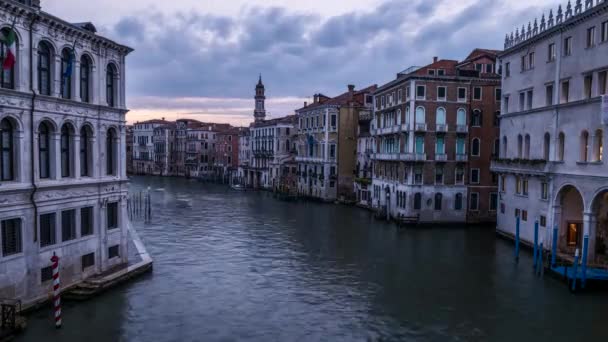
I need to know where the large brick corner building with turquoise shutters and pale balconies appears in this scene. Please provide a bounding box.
[372,49,501,222]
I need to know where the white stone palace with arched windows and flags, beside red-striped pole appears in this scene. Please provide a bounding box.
[0,0,132,305]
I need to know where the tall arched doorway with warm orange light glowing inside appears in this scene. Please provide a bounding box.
[555,185,584,254]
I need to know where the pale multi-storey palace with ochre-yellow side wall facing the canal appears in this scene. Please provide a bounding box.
[296,85,376,201]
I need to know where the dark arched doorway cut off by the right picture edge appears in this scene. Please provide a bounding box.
[590,189,608,266]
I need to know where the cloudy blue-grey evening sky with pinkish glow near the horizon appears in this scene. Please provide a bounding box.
[42,0,561,125]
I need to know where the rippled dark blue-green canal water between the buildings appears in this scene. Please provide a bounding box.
[18,177,608,342]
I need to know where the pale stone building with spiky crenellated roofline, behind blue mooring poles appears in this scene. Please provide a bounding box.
[493,1,608,265]
